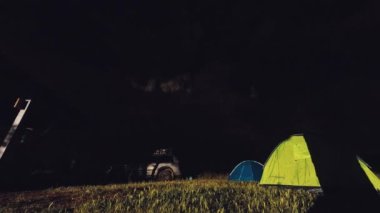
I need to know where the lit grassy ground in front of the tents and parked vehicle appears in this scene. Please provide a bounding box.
[0,179,317,212]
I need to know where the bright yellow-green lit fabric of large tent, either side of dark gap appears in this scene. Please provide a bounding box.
[260,135,380,191]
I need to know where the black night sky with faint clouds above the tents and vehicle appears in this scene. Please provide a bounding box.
[0,0,380,201]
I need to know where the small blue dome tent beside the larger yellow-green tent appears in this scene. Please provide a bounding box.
[228,160,263,182]
